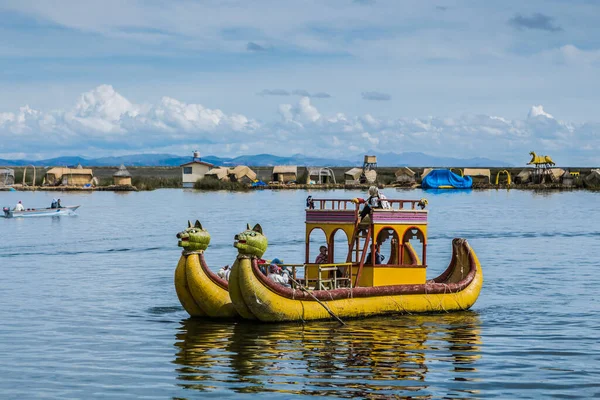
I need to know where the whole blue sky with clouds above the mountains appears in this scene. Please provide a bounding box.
[0,0,600,166]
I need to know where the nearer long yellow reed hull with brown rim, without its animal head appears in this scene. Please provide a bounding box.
[234,239,483,322]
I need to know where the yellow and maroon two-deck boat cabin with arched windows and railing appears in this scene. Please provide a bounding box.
[305,199,427,289]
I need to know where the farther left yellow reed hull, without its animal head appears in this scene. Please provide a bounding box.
[175,253,239,318]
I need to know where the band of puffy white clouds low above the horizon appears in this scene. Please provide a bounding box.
[0,85,600,165]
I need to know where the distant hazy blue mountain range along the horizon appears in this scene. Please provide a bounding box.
[0,151,513,167]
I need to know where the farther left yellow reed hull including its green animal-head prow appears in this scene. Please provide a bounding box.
[175,221,239,318]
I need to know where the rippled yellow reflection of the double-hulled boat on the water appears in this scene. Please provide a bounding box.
[174,312,481,398]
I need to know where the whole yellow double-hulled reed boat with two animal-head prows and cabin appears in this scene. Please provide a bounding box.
[175,195,483,322]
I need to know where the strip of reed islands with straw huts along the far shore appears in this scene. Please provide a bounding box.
[0,152,600,191]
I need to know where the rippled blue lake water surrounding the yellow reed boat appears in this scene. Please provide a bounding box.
[0,189,600,399]
